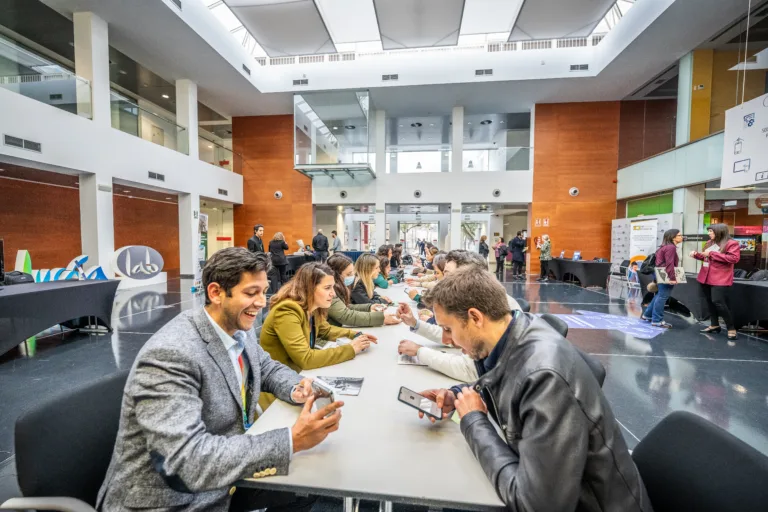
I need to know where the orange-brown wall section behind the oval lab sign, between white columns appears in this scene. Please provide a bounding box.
[112,195,179,272]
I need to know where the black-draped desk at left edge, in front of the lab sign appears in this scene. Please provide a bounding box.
[0,280,120,354]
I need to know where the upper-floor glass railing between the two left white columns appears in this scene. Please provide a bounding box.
[109,91,189,155]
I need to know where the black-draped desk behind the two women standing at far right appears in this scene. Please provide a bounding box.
[640,274,768,329]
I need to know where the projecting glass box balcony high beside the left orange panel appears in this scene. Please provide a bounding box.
[293,91,368,166]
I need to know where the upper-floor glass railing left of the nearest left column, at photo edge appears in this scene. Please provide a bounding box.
[0,37,92,119]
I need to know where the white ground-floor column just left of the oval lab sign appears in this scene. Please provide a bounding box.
[79,174,115,278]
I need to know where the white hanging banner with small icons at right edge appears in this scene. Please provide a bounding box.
[720,94,768,188]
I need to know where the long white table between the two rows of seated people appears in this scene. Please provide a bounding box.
[237,285,504,511]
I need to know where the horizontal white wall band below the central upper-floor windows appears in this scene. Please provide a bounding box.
[312,171,533,205]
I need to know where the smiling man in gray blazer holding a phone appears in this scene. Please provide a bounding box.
[97,247,343,512]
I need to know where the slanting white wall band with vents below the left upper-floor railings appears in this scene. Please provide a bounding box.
[0,85,243,204]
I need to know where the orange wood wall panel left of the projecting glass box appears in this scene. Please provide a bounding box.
[232,115,313,253]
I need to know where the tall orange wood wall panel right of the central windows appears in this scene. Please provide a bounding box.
[529,101,621,272]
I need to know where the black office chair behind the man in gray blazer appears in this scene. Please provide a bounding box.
[0,371,128,511]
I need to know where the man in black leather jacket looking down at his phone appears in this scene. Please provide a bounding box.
[419,269,653,512]
